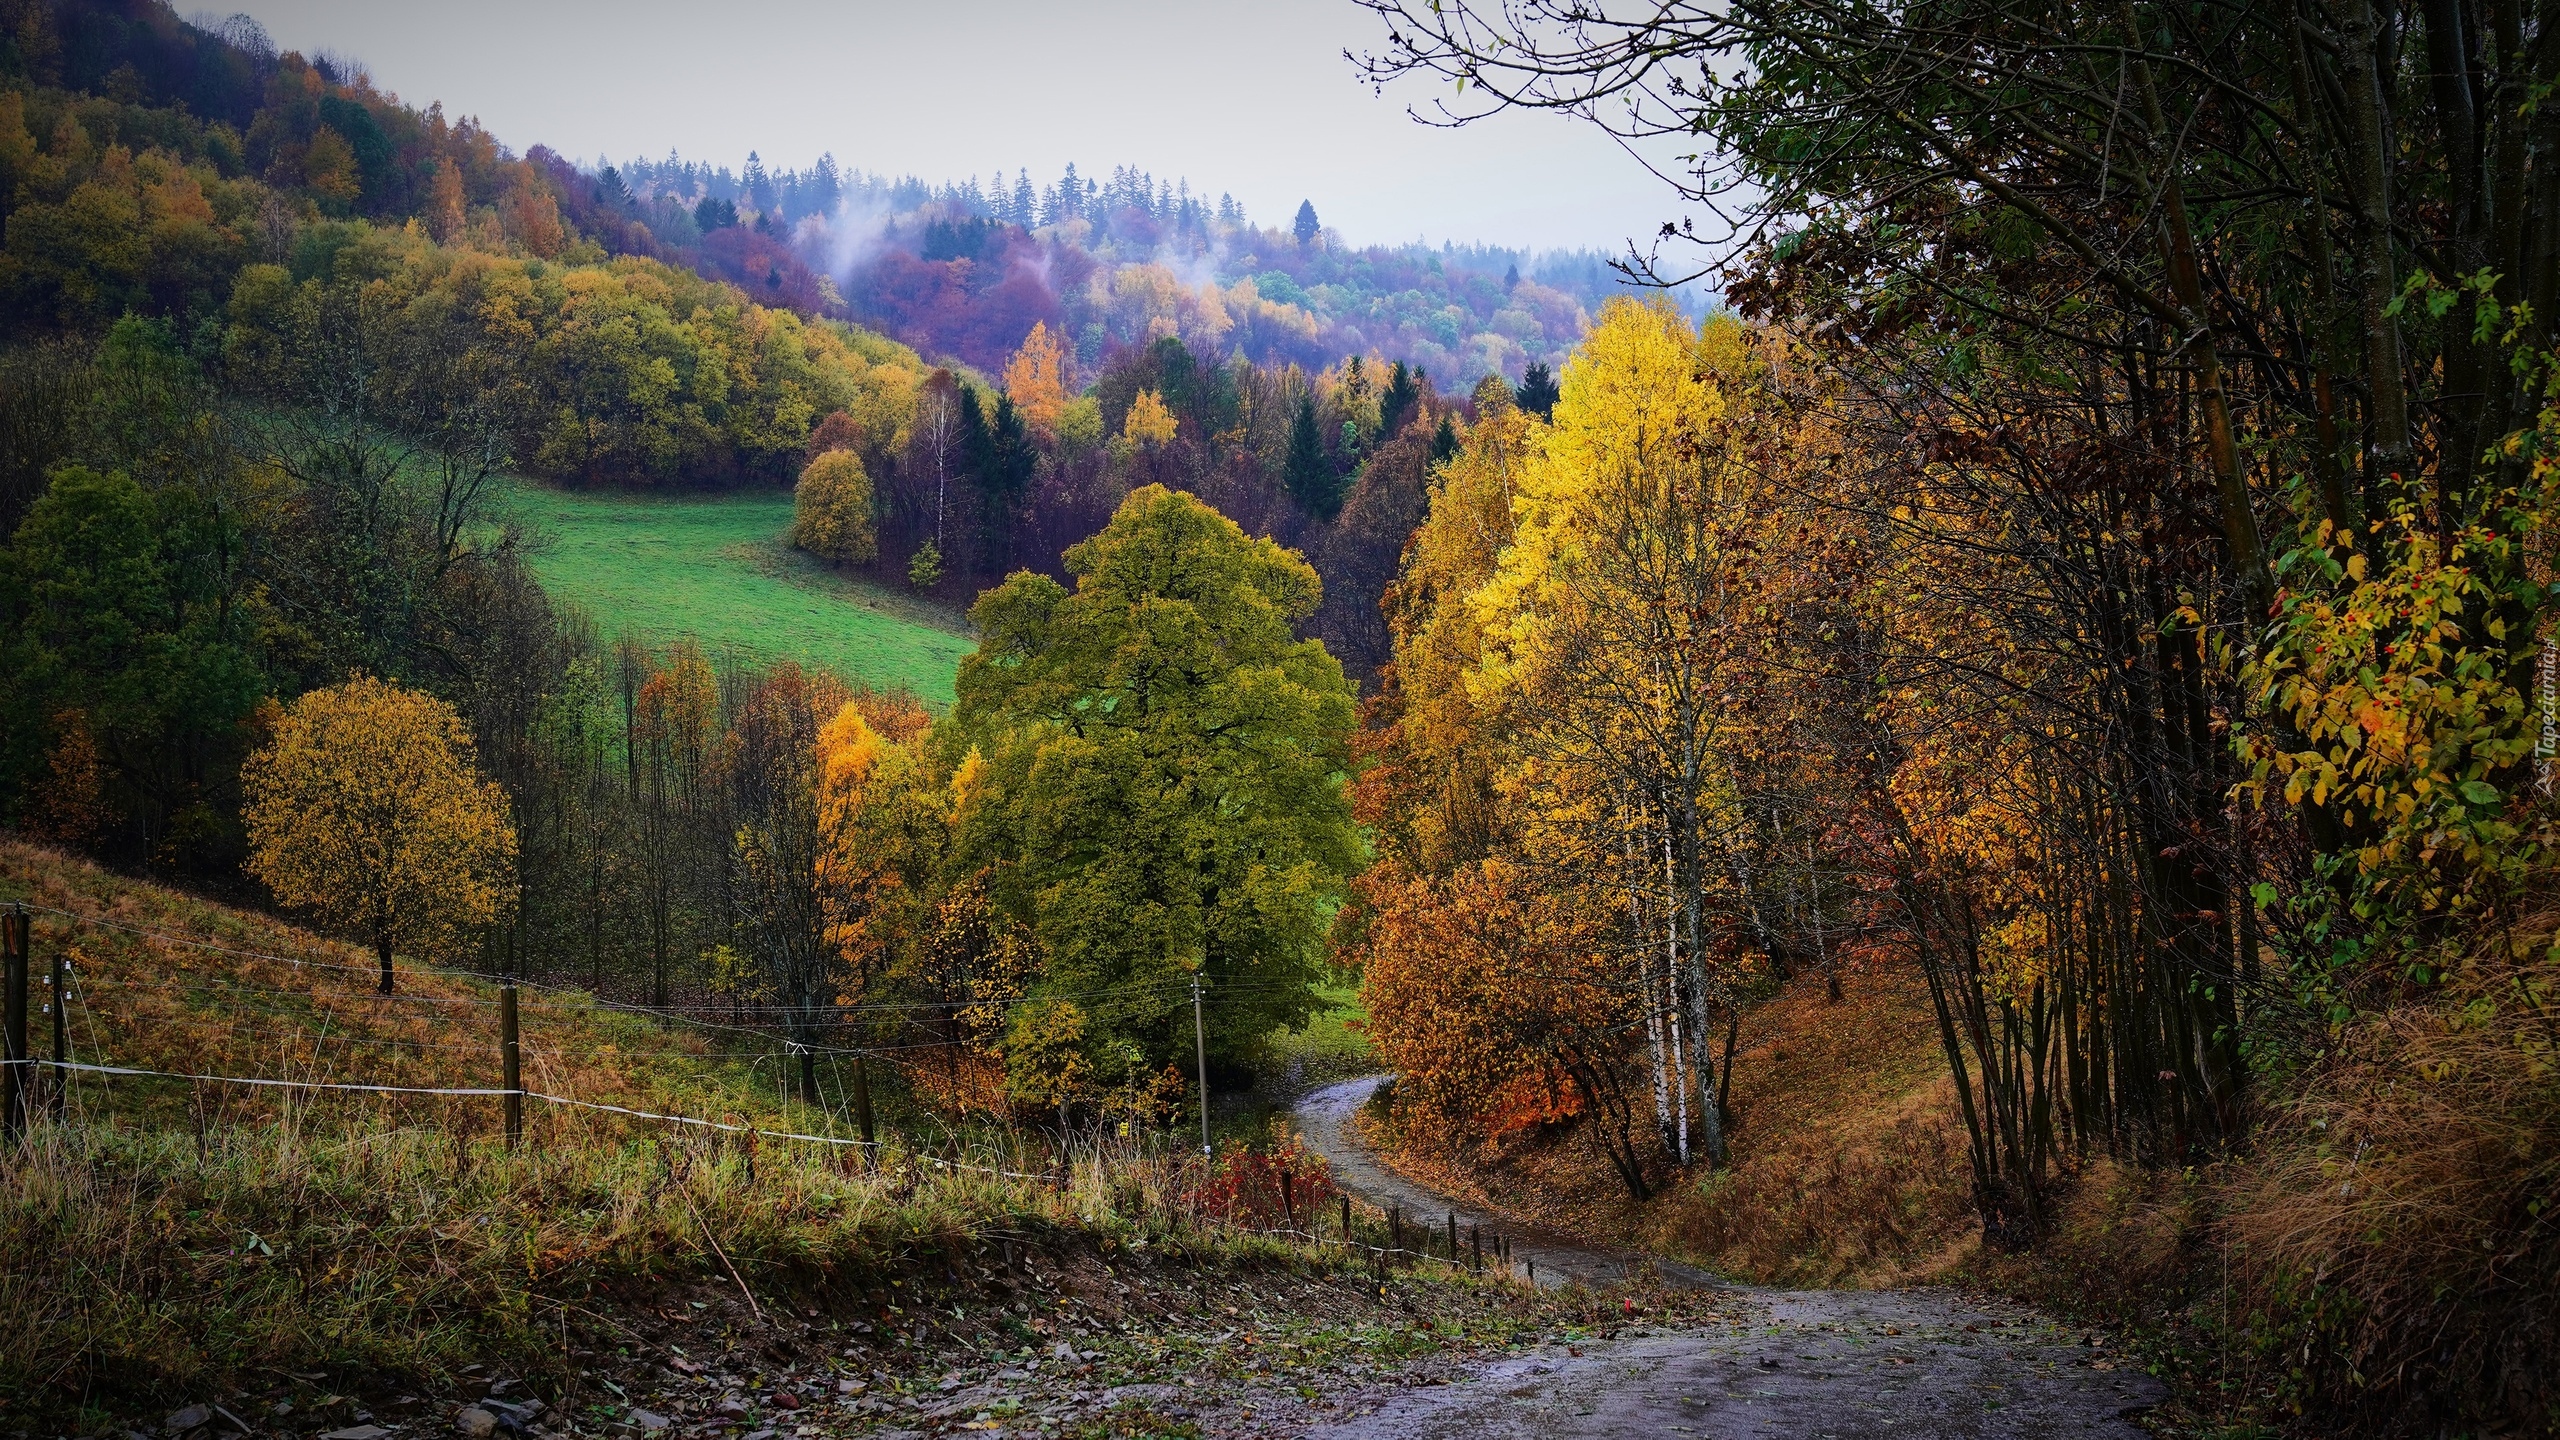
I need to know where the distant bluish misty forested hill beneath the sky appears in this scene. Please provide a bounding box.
[606,154,1687,384]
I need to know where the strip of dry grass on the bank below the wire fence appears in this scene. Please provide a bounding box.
[0,1115,1267,1427]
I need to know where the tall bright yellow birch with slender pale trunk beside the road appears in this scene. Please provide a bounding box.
[1472,302,1812,1163]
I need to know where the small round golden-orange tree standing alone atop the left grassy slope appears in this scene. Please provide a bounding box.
[241,676,515,994]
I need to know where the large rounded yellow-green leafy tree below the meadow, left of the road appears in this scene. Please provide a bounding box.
[937,484,1364,1074]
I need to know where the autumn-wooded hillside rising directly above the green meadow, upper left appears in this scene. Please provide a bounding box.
[0,0,924,504]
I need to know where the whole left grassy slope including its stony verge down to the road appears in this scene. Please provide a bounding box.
[0,840,1669,1440]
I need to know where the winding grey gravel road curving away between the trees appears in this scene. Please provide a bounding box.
[1295,1076,2166,1440]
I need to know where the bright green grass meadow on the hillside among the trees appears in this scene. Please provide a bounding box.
[499,482,973,707]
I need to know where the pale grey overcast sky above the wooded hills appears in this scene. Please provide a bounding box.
[215,0,1677,251]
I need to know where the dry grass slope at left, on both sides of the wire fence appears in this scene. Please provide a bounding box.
[0,843,1320,1432]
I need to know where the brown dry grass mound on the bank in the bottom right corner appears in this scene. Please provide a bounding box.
[2227,953,2560,1432]
